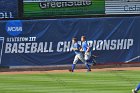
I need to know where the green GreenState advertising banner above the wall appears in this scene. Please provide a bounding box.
[23,0,105,17]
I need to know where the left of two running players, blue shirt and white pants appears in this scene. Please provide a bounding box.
[69,38,91,72]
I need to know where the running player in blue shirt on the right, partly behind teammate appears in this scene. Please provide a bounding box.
[81,36,96,65]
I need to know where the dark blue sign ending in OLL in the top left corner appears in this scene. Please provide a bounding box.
[0,0,18,19]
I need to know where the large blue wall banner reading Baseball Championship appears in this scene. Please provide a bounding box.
[0,17,140,66]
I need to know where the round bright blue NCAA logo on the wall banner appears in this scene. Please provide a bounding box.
[6,20,23,36]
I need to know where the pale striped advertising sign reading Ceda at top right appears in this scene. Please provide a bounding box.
[105,0,140,14]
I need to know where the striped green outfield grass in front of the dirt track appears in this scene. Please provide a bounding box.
[0,71,140,93]
